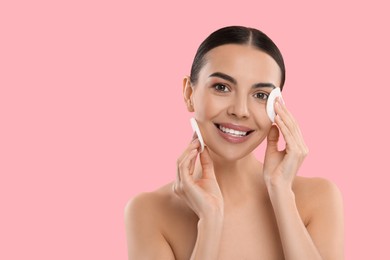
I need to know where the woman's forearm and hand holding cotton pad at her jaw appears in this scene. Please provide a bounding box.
[173,142,224,260]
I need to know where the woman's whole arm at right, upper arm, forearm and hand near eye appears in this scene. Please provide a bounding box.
[263,99,343,260]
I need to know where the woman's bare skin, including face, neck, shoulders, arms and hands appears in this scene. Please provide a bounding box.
[125,44,344,260]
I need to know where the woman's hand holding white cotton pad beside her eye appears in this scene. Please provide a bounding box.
[263,98,308,188]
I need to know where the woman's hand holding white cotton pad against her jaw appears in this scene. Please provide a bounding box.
[173,139,223,219]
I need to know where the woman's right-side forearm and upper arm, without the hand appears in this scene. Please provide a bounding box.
[268,180,344,260]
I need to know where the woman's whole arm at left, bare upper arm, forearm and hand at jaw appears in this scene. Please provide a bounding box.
[125,140,223,260]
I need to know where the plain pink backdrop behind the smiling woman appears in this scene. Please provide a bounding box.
[0,0,390,259]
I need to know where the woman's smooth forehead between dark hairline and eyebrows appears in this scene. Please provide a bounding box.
[199,44,281,86]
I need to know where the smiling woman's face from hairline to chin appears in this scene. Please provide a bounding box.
[187,44,281,160]
